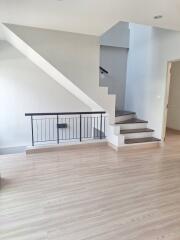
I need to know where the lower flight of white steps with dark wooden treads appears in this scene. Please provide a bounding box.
[115,111,160,144]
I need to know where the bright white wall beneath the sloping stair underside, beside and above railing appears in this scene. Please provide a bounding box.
[0,41,90,152]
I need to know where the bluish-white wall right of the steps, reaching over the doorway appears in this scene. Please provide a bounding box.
[125,24,180,138]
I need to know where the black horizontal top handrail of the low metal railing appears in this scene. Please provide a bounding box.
[25,111,106,117]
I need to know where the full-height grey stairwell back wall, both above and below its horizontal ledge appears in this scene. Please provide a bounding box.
[100,22,130,110]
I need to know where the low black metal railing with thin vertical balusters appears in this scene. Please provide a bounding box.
[25,111,106,146]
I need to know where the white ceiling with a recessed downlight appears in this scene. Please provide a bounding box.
[0,0,180,35]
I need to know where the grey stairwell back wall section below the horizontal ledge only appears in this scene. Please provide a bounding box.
[100,46,128,110]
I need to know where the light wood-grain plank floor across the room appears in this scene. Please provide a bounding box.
[0,130,180,240]
